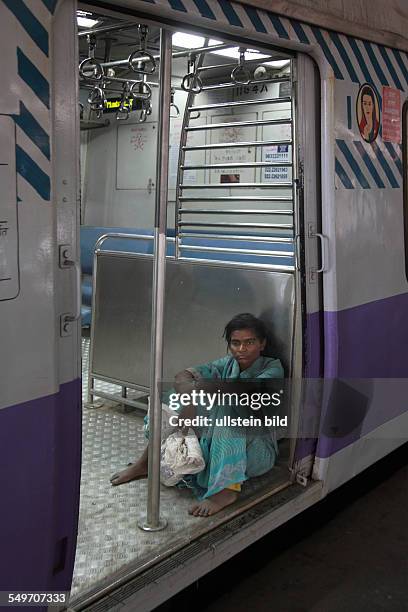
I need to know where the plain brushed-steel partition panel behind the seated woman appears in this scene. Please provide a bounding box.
[90,252,294,389]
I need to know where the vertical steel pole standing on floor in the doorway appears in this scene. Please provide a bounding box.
[139,29,171,531]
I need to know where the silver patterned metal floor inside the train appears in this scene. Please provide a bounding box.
[71,338,290,602]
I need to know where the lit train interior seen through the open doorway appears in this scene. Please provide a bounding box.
[72,5,296,599]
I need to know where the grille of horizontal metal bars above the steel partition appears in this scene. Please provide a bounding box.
[175,54,296,271]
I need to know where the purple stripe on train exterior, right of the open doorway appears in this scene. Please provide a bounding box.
[316,293,408,457]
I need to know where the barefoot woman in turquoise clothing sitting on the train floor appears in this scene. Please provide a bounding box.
[111,313,284,516]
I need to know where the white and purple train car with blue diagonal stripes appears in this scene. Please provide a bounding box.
[0,0,408,610]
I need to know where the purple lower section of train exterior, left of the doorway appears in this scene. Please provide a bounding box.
[0,380,81,591]
